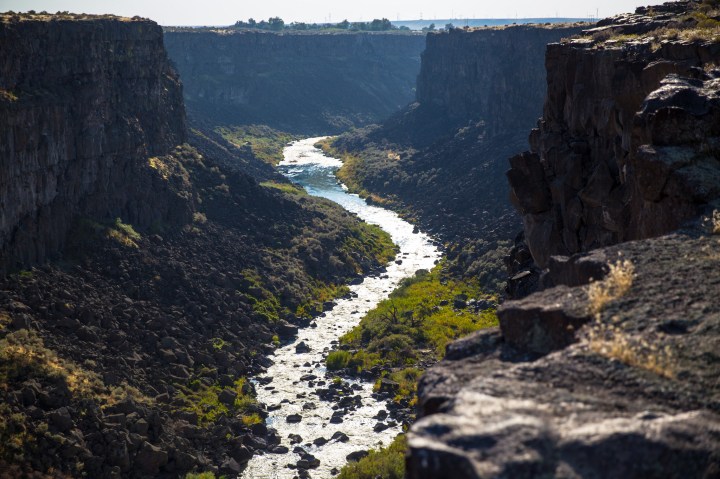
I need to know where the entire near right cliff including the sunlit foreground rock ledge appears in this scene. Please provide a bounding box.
[407,2,720,478]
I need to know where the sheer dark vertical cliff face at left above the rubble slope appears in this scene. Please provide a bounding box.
[0,16,188,270]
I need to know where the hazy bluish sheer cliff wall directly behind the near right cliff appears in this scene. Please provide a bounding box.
[417,25,580,135]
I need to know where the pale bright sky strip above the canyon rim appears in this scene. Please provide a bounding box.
[0,0,662,25]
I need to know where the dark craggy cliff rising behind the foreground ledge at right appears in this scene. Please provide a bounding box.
[508,3,720,267]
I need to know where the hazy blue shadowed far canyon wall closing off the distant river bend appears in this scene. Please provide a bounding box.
[165,31,425,135]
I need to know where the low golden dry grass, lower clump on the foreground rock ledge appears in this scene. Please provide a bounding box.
[588,322,675,379]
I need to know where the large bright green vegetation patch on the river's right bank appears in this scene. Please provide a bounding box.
[326,263,497,402]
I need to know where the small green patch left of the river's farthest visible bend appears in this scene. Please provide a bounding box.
[216,125,299,165]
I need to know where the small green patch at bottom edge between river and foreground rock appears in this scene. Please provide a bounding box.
[337,434,407,479]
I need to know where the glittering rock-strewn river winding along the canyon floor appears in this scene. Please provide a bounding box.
[242,138,440,479]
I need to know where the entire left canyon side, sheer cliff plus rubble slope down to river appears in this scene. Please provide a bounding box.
[0,13,394,477]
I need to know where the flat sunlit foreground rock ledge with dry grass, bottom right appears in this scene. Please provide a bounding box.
[408,231,720,478]
